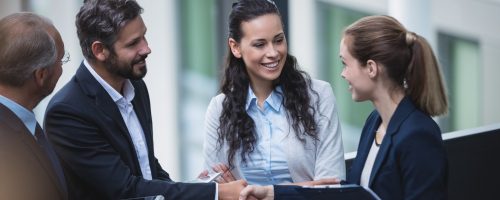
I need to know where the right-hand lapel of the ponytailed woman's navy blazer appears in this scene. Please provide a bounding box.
[368,97,415,187]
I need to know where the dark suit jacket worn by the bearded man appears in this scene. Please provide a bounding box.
[45,63,215,200]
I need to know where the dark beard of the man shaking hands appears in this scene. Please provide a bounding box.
[104,52,148,80]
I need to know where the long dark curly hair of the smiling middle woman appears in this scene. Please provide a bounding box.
[217,0,318,168]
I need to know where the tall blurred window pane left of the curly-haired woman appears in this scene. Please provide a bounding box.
[178,0,220,180]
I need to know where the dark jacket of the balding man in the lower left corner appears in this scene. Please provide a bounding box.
[0,104,67,200]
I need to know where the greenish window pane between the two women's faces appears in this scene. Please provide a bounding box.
[318,2,373,152]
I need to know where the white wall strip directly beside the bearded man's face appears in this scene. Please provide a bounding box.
[138,0,181,180]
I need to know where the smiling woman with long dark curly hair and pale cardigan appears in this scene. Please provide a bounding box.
[204,0,345,185]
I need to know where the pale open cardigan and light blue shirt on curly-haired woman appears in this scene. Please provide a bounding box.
[203,79,345,184]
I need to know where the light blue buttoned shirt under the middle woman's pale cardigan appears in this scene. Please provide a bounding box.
[241,87,293,185]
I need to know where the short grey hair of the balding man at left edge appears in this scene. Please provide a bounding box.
[0,12,57,86]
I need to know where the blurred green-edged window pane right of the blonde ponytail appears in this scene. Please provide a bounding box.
[438,33,482,132]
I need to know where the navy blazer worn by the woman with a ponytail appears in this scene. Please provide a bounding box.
[347,97,448,200]
